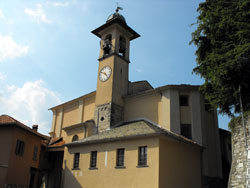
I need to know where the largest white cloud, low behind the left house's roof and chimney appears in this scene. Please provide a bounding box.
[0,80,61,134]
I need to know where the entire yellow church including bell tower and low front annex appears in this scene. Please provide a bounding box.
[48,9,222,188]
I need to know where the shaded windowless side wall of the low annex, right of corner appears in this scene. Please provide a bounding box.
[159,138,201,188]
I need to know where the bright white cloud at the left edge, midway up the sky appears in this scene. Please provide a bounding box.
[0,35,29,62]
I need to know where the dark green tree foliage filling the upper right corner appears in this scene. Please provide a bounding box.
[191,0,250,116]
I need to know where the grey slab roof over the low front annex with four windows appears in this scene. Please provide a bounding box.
[65,119,201,147]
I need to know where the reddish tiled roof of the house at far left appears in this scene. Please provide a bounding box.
[0,115,49,139]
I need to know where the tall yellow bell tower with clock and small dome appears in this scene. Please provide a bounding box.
[92,7,140,132]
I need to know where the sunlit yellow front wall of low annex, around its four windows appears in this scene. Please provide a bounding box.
[63,138,159,188]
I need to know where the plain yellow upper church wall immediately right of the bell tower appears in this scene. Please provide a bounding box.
[124,93,162,125]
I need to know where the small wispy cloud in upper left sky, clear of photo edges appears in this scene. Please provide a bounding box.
[24,4,52,23]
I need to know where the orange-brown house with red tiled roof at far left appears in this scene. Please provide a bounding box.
[0,115,49,188]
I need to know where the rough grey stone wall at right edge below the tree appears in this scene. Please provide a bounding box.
[228,113,250,188]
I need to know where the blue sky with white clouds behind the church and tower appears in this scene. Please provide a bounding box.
[0,0,229,133]
